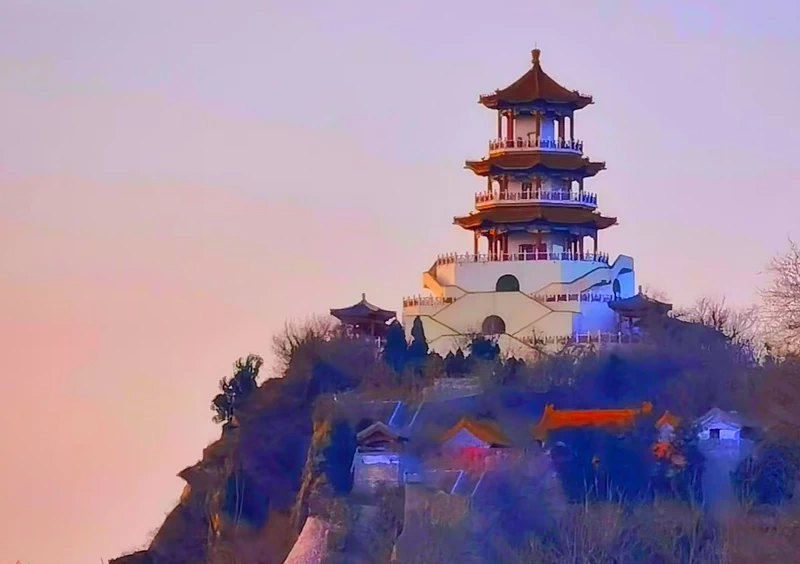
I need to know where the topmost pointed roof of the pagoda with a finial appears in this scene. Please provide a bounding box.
[479,49,592,110]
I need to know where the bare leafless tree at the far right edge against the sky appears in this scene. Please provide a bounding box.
[761,240,800,355]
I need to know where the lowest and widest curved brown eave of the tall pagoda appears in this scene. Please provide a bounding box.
[453,205,617,230]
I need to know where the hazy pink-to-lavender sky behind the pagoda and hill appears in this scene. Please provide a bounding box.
[0,0,800,564]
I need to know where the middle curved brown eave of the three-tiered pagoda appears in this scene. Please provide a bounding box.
[465,152,606,178]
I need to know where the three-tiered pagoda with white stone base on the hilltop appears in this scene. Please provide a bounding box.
[403,49,634,354]
